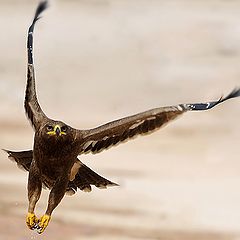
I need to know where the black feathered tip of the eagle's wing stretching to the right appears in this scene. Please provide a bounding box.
[180,88,240,111]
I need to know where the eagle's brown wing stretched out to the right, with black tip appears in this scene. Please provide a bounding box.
[78,89,240,154]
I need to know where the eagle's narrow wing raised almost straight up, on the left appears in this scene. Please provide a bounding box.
[24,1,47,129]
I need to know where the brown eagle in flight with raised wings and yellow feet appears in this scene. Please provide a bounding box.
[5,1,240,233]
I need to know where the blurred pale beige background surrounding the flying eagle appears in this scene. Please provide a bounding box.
[0,0,240,240]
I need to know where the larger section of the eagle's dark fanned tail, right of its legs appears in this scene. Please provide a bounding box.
[66,164,119,195]
